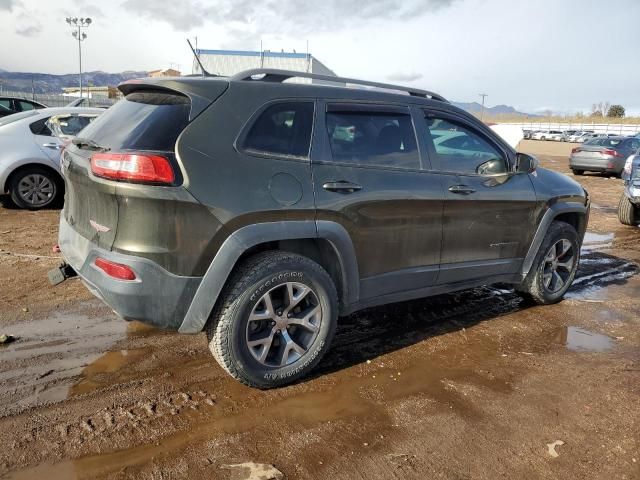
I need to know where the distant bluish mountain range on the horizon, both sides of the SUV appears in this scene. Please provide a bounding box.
[0,69,537,117]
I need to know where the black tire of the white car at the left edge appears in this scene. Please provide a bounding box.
[9,166,64,210]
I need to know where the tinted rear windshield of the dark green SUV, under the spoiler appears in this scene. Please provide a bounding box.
[80,91,191,151]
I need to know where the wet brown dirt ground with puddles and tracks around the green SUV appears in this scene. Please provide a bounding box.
[0,141,640,480]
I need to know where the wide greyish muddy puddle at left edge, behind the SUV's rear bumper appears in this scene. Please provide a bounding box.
[0,302,158,417]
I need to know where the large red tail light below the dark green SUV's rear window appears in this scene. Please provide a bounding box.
[91,153,175,185]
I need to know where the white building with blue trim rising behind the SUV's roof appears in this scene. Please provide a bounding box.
[192,49,336,83]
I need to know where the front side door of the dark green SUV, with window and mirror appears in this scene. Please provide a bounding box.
[419,110,536,284]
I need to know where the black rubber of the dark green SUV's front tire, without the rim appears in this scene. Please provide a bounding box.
[516,221,580,305]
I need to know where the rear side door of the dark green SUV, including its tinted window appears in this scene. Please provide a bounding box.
[311,101,443,300]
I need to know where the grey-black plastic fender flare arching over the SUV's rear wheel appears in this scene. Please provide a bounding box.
[178,220,360,333]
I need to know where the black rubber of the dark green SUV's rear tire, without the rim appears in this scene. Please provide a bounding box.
[206,251,338,389]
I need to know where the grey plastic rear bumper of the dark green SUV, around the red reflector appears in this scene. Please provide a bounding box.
[59,217,202,330]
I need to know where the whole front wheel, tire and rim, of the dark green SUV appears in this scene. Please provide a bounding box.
[516,221,580,305]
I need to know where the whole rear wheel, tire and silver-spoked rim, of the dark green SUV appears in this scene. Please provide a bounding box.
[207,251,338,388]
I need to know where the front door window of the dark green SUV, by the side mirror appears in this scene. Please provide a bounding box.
[425,116,508,175]
